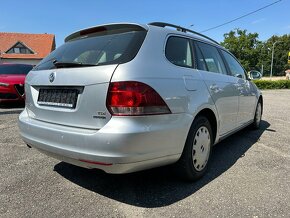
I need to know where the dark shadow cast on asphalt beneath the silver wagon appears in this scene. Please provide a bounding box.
[54,121,273,208]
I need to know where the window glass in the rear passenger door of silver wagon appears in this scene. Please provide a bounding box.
[196,42,227,74]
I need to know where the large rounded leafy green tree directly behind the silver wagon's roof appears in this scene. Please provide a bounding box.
[221,29,263,71]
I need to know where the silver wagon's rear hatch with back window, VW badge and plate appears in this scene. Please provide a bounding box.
[25,24,146,129]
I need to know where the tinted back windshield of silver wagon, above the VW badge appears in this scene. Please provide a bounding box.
[34,28,146,70]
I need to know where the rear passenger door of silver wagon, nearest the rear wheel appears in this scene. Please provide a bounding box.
[194,41,238,136]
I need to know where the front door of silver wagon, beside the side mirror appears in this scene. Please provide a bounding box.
[221,50,256,126]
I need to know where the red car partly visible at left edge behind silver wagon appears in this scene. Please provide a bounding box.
[0,64,33,103]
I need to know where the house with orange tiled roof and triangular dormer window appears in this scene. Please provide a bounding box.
[0,32,55,65]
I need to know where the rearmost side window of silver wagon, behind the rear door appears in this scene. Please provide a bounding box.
[165,36,193,67]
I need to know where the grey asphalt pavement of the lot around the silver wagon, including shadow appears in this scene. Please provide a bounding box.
[0,90,290,217]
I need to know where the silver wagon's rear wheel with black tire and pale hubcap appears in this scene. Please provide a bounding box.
[176,116,213,181]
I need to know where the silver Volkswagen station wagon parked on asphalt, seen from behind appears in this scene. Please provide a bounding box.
[19,22,263,181]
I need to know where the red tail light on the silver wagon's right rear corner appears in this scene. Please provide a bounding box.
[107,81,171,116]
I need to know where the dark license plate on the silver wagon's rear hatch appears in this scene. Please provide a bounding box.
[37,89,79,108]
